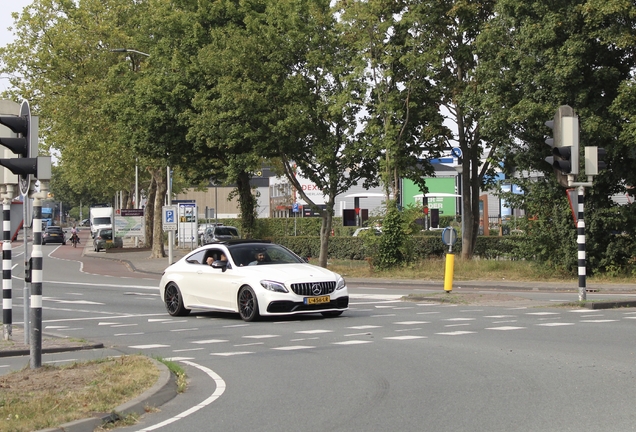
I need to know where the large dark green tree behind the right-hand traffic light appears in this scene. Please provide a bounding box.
[478,0,636,272]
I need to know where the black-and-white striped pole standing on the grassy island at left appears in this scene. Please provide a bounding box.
[30,180,49,369]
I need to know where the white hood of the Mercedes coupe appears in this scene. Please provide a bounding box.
[239,264,338,283]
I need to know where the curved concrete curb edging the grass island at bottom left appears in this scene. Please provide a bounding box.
[37,358,177,432]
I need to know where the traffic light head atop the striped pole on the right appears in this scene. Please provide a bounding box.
[545,105,579,187]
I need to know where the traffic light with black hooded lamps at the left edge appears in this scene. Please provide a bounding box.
[0,100,51,195]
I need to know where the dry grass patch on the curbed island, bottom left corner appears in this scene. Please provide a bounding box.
[0,355,159,432]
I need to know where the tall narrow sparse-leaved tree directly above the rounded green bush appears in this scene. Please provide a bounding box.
[336,0,450,205]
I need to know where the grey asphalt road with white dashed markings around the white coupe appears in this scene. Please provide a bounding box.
[0,240,636,432]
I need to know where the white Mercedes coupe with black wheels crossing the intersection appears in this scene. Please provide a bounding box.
[159,240,349,321]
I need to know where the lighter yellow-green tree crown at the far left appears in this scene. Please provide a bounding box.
[0,0,139,201]
